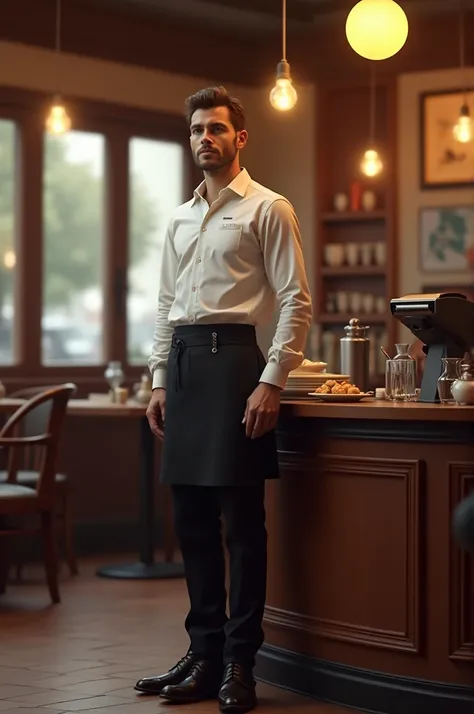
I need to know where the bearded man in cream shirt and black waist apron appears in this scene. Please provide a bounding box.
[136,87,311,712]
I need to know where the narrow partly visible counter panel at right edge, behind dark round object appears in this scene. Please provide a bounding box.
[448,461,474,662]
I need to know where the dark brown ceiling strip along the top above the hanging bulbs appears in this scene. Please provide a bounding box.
[93,0,474,36]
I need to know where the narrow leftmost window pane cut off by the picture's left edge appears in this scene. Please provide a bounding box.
[0,119,17,364]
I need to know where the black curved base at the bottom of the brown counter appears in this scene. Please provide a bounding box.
[255,644,474,714]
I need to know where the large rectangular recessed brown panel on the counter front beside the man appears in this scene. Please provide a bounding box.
[265,454,422,652]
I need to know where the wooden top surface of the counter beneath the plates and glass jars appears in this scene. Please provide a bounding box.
[281,399,474,422]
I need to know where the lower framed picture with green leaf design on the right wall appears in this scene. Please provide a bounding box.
[419,206,474,273]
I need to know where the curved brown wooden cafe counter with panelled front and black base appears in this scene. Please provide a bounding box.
[256,400,474,714]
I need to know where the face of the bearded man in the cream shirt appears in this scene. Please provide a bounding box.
[190,107,247,172]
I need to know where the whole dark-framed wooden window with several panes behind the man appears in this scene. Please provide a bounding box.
[0,87,193,382]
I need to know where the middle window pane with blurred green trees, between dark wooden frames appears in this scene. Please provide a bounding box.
[41,131,105,364]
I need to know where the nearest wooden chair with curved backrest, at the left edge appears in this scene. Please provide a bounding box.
[0,384,76,603]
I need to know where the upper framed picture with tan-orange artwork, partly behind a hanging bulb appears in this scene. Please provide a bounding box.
[420,91,474,188]
